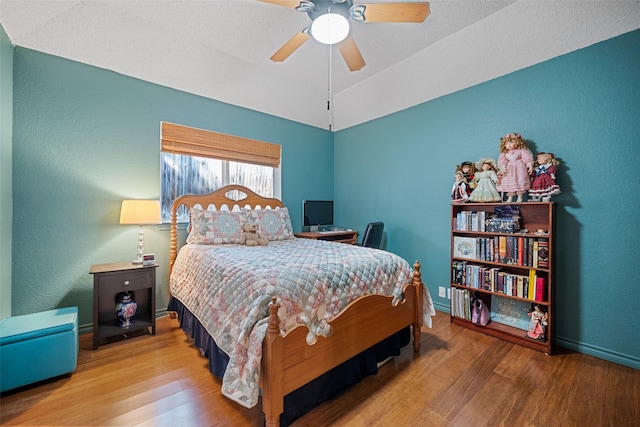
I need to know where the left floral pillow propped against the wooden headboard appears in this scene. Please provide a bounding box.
[187,208,247,245]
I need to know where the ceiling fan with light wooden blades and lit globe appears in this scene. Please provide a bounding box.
[259,0,429,71]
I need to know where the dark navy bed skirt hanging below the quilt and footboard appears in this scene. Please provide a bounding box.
[167,297,411,427]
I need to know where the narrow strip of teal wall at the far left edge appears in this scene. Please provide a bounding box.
[0,26,13,319]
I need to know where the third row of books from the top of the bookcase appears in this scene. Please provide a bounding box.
[451,261,547,302]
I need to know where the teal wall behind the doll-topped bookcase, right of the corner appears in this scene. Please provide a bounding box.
[334,31,640,369]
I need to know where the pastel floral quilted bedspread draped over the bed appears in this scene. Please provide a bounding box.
[170,238,433,408]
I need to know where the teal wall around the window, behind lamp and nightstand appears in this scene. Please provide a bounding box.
[13,47,333,326]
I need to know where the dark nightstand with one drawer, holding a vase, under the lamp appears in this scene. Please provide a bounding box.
[89,262,158,350]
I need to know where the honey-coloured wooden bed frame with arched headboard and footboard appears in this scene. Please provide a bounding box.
[169,185,424,427]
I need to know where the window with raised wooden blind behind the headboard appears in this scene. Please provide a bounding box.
[160,122,280,222]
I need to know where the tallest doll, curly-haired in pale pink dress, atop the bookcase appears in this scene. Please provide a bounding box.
[496,133,533,202]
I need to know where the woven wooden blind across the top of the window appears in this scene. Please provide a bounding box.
[160,122,280,168]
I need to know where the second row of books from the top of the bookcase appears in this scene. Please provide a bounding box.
[453,236,549,268]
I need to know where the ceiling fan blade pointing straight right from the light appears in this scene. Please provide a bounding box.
[351,2,429,23]
